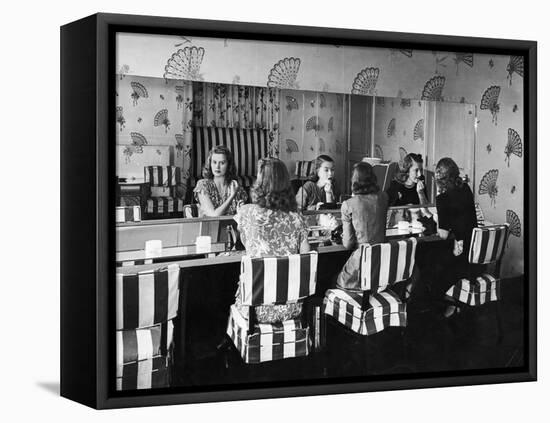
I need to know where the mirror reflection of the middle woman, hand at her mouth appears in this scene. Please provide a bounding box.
[296,154,340,210]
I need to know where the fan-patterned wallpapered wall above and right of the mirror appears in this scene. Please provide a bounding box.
[117,34,525,275]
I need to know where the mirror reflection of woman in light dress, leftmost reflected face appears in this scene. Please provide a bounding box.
[193,145,248,216]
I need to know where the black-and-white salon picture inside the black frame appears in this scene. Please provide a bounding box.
[113,31,527,392]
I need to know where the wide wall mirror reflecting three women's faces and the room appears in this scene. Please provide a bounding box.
[117,77,475,229]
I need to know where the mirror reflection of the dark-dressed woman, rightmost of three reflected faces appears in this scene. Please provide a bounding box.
[386,153,428,207]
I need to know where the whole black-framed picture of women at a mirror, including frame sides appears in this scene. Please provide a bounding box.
[61,14,537,408]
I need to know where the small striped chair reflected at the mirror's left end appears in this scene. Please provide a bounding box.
[144,166,183,219]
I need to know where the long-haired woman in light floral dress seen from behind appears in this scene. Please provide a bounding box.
[234,158,310,323]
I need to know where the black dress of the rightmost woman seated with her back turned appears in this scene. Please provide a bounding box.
[432,184,477,298]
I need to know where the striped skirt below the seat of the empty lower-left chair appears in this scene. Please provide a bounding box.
[116,356,170,391]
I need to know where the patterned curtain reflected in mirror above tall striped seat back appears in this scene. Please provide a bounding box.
[192,82,280,157]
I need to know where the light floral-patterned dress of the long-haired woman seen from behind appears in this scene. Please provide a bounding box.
[234,204,308,323]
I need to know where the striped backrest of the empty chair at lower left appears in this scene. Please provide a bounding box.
[116,264,180,330]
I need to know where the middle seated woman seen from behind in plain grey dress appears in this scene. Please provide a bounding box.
[336,162,388,290]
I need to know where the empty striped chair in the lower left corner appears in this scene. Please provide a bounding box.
[116,264,180,390]
